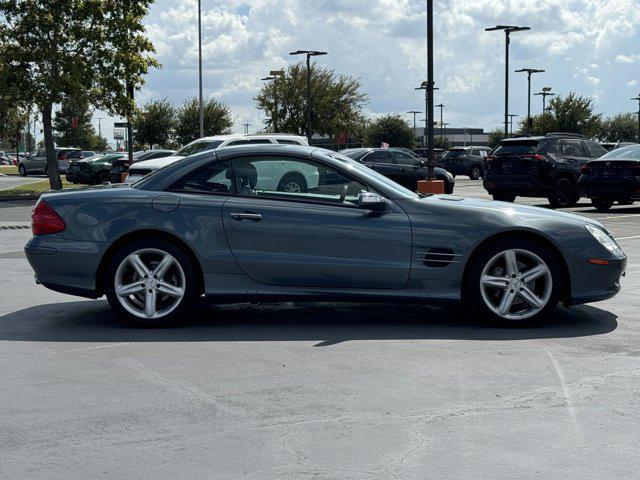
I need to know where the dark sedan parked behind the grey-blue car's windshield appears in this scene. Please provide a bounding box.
[340,148,455,193]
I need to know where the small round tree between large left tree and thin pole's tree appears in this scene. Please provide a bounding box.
[133,98,176,148]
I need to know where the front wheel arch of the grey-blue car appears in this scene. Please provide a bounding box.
[461,230,571,305]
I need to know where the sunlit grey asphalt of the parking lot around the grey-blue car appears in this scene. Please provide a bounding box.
[0,178,640,480]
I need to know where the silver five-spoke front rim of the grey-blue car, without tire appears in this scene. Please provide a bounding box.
[480,249,553,320]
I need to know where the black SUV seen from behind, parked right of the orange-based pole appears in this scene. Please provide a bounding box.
[484,133,607,208]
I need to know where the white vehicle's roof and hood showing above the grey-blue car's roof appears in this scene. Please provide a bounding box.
[125,134,309,183]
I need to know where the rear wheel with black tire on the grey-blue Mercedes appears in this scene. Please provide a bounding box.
[104,239,198,327]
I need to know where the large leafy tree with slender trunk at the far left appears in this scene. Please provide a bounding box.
[0,0,158,189]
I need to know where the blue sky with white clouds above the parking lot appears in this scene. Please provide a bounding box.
[94,0,640,146]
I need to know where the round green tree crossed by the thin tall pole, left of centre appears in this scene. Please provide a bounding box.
[175,98,233,145]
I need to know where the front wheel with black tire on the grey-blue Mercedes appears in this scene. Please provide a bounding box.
[463,238,562,327]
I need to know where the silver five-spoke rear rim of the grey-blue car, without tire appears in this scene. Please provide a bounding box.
[114,248,186,319]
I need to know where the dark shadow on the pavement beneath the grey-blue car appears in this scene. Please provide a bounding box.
[0,300,618,346]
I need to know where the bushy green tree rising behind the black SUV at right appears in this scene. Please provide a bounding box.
[520,92,601,137]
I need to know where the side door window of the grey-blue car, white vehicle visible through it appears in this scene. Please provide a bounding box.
[231,156,369,205]
